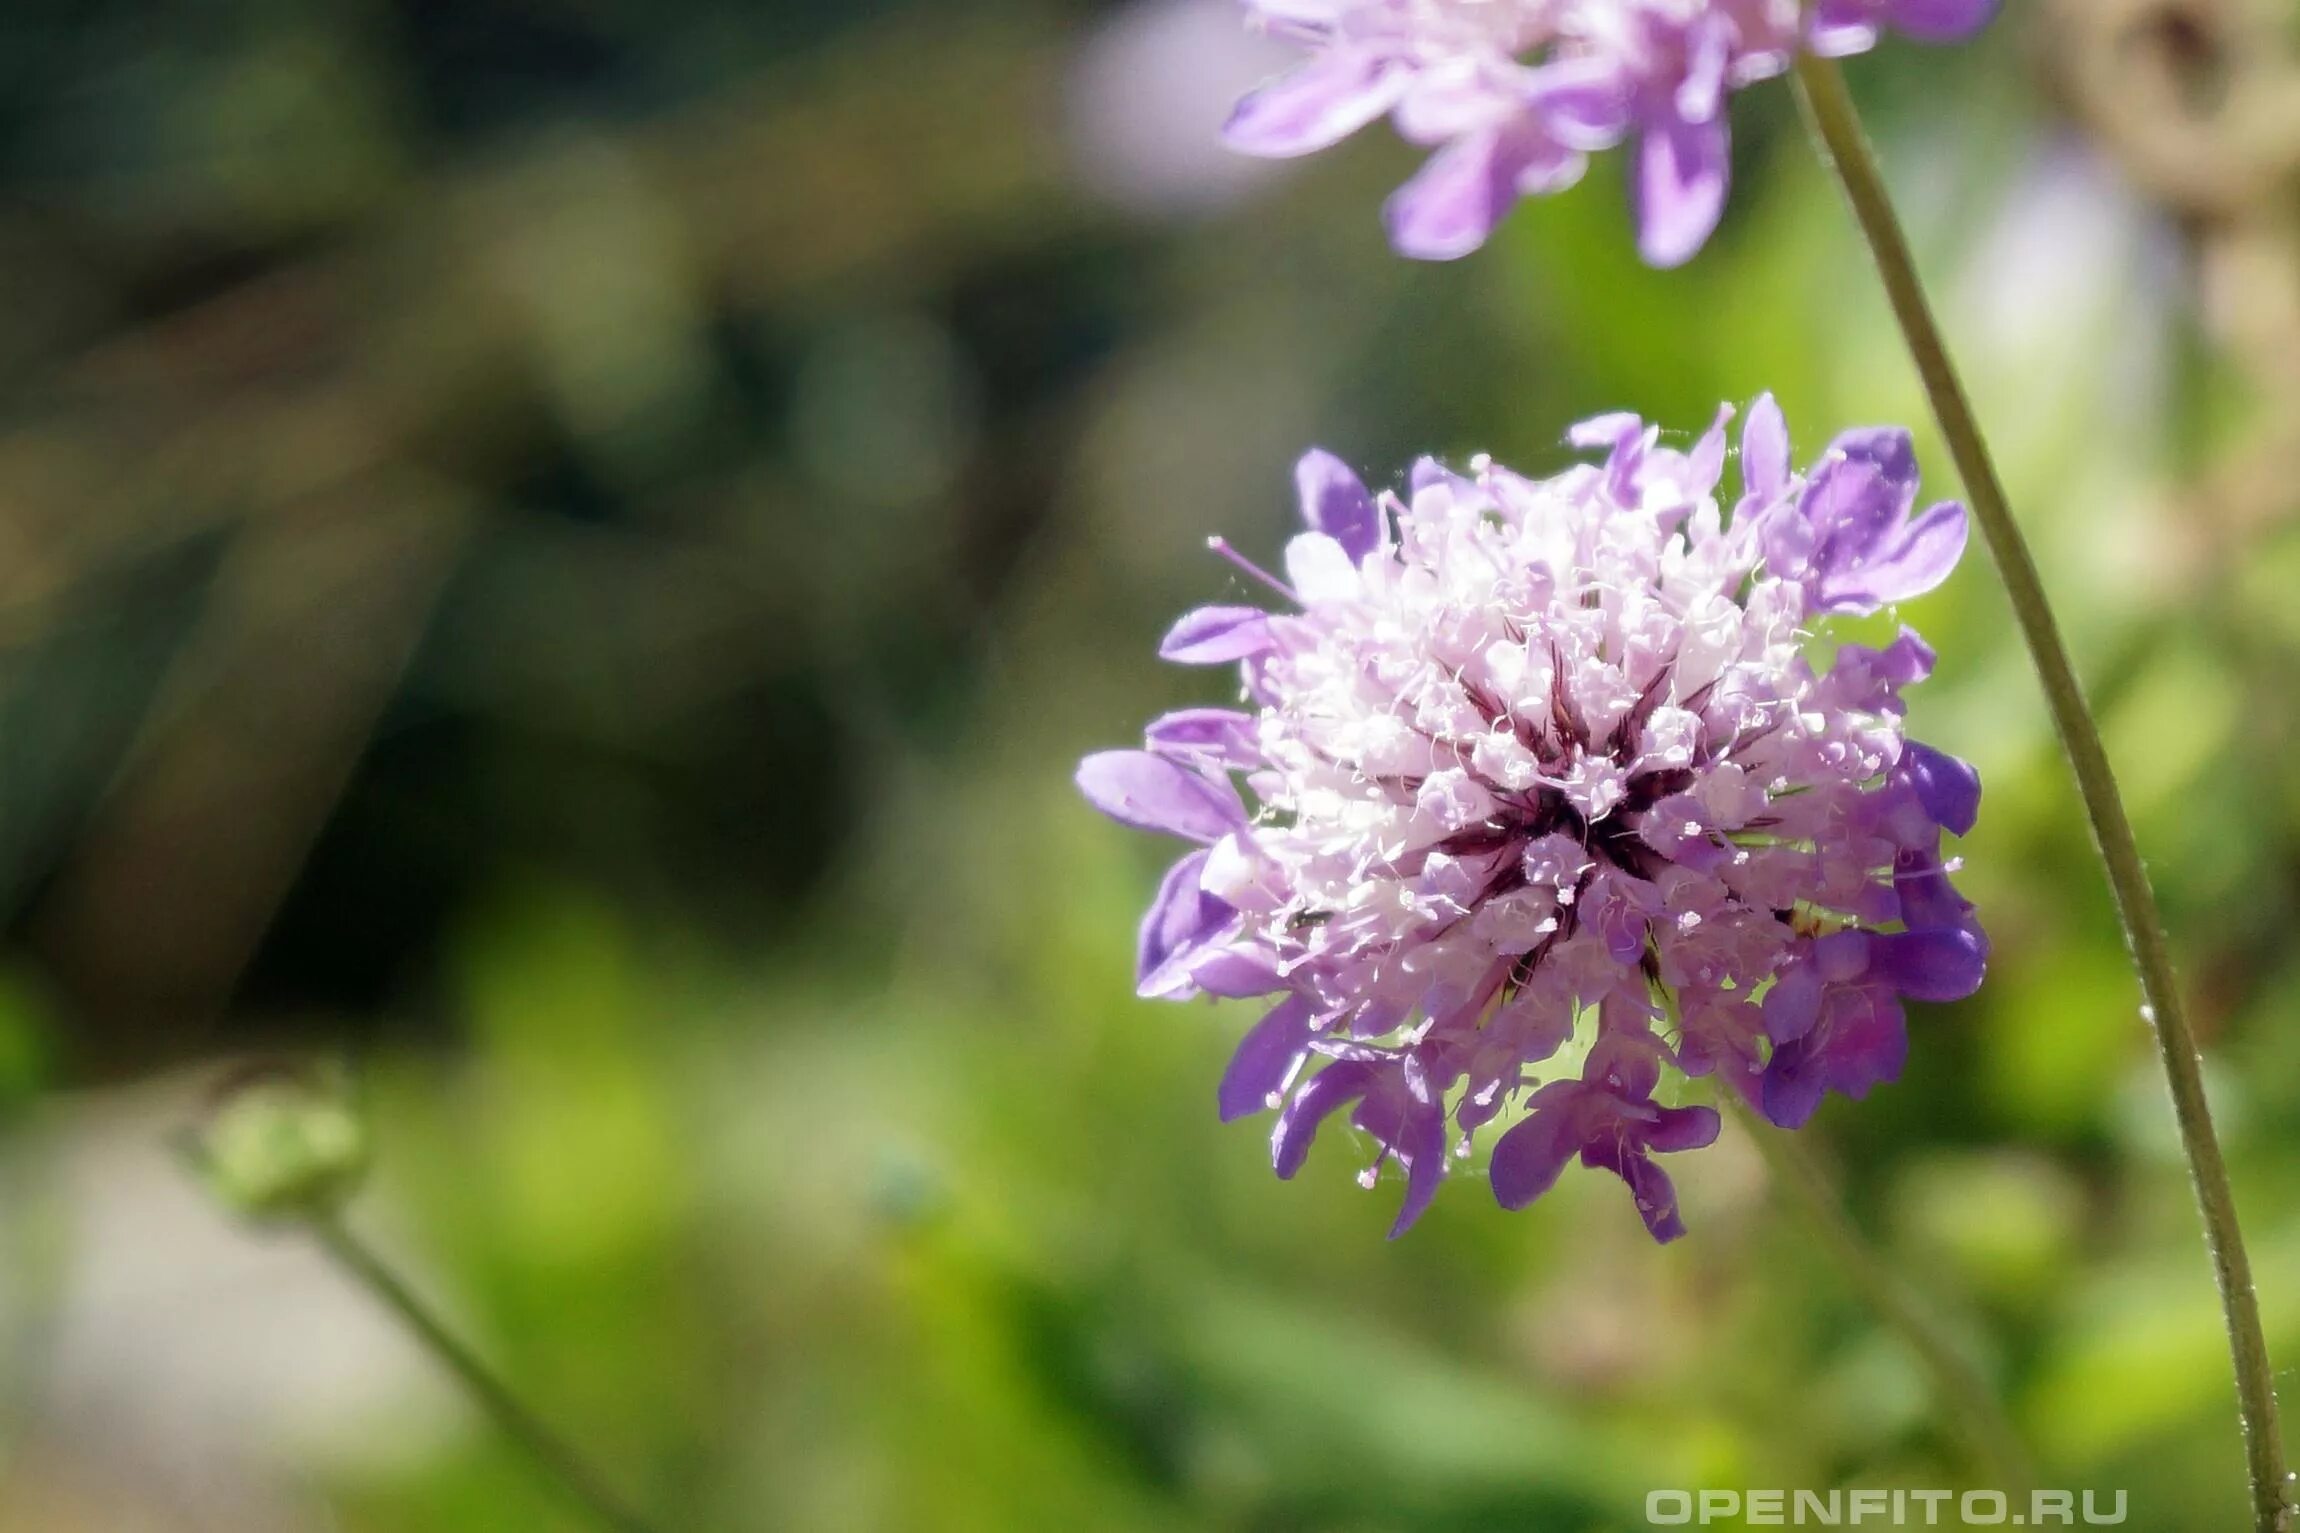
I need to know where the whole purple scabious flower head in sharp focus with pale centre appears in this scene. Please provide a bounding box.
[1079,398,1987,1241]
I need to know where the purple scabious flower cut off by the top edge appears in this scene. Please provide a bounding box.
[1226,0,1996,267]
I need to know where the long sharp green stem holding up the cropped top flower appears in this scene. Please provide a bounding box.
[1796,55,2291,1533]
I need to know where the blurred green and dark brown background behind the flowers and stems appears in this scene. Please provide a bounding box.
[0,0,2300,1533]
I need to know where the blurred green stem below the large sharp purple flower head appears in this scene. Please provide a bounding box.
[1718,1089,2036,1501]
